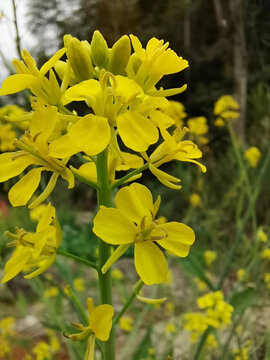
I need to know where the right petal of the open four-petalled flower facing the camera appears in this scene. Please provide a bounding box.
[157,222,195,257]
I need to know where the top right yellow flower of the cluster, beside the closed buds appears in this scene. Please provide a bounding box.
[126,35,188,96]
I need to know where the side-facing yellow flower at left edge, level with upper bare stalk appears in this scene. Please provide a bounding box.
[0,107,74,207]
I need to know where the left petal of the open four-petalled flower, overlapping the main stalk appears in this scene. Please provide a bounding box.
[93,206,136,245]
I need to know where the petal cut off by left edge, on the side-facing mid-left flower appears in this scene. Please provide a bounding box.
[0,152,32,182]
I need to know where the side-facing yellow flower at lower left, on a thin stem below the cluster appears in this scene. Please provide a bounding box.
[2,204,62,283]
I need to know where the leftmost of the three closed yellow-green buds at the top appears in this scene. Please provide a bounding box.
[64,35,94,82]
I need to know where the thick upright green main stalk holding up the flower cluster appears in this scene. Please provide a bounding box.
[96,149,115,360]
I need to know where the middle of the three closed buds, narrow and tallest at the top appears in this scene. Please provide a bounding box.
[91,30,109,68]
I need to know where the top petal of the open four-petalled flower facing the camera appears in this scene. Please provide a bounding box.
[115,183,153,223]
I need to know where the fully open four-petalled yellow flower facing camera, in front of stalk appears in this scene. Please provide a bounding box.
[93,183,195,285]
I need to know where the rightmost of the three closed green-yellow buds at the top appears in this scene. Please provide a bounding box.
[109,35,131,75]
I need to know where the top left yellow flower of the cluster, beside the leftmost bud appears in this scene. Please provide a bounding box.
[0,48,66,105]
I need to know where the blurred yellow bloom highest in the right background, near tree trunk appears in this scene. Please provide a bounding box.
[214,95,239,120]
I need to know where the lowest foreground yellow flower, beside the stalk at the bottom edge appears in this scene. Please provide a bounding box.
[66,298,114,360]
